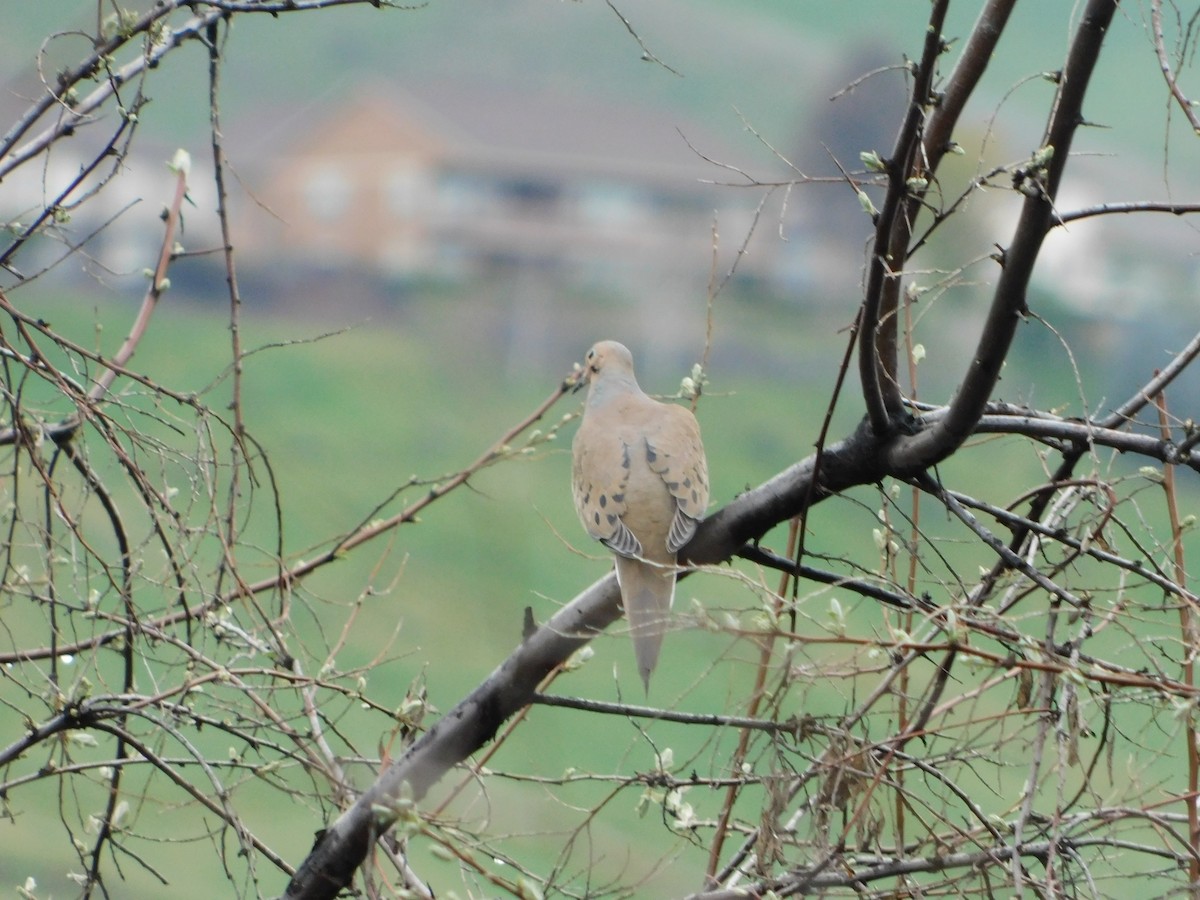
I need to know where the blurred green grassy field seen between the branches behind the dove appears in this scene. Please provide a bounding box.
[0,283,1195,898]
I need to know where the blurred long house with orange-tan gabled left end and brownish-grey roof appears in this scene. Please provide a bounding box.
[239,84,768,289]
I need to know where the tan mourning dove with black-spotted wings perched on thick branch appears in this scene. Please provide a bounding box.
[572,341,708,690]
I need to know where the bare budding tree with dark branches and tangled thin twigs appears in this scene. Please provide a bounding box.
[0,0,1200,898]
